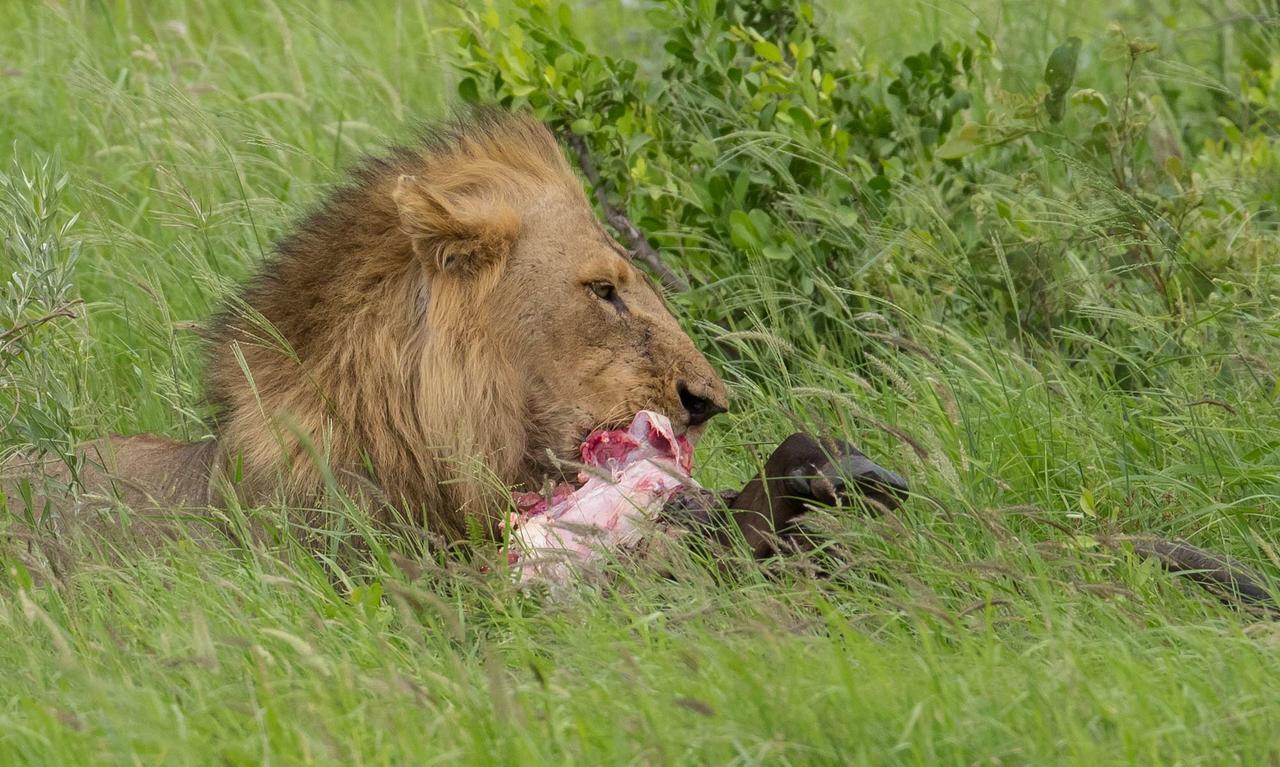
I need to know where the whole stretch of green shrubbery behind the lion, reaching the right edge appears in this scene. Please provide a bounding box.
[458,0,1280,373]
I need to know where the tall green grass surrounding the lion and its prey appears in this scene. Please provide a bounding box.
[0,0,1280,766]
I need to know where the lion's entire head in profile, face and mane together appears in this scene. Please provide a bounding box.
[211,113,727,535]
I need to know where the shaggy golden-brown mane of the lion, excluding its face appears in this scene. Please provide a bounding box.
[207,110,589,533]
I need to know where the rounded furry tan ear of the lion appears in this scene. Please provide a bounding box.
[392,175,520,277]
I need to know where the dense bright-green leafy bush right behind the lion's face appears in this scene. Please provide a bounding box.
[460,1,973,326]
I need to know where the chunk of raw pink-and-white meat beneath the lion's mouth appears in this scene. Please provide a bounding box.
[507,410,698,585]
